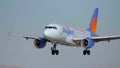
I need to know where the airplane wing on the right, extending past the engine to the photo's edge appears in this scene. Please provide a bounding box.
[73,35,120,42]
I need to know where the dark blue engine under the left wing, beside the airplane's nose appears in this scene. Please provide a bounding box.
[34,38,47,48]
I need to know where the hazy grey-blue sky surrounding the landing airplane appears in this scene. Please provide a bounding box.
[0,0,120,68]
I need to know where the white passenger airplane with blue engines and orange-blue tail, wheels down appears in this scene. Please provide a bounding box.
[23,8,120,55]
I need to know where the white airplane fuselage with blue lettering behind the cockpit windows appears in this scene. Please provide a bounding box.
[43,24,90,46]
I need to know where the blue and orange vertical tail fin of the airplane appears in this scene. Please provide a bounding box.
[87,8,98,34]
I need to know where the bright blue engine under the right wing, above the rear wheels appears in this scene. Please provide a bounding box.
[82,38,95,49]
